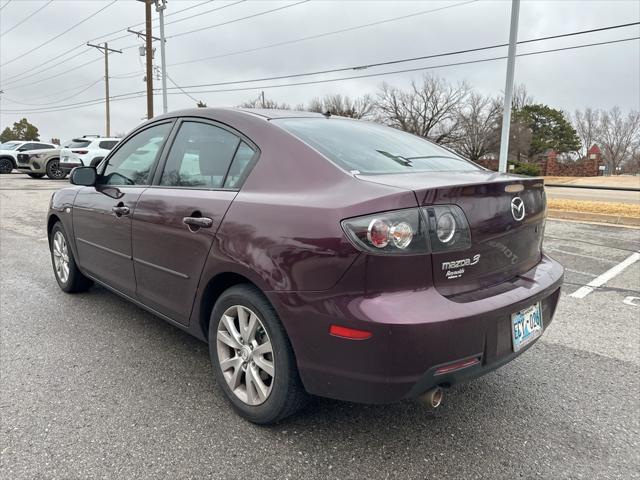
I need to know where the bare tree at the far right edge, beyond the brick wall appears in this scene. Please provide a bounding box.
[598,107,640,174]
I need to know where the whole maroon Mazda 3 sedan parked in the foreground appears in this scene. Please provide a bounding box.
[48,109,563,423]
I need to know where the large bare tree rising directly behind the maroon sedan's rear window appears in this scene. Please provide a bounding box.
[376,75,470,144]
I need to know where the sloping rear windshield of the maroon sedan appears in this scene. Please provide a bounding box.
[272,118,480,174]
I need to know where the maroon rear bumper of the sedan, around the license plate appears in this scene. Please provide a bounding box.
[270,256,564,403]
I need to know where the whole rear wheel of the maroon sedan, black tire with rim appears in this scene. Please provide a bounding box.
[209,284,309,425]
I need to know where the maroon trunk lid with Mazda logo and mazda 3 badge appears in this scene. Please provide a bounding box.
[358,170,546,296]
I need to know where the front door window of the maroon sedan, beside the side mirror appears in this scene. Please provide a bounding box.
[98,123,171,186]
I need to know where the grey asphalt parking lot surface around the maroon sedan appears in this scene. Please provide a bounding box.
[0,174,640,480]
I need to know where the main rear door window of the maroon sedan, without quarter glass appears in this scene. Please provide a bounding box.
[160,122,240,188]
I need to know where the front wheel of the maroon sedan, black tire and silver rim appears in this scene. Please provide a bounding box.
[49,222,93,293]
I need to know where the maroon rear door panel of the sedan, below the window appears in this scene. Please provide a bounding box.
[132,187,237,325]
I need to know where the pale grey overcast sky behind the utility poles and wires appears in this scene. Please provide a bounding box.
[0,0,640,140]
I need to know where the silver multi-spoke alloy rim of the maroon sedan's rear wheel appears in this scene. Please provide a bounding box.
[216,305,275,406]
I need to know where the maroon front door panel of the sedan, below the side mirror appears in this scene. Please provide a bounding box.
[73,187,146,296]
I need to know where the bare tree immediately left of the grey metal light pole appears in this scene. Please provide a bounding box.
[453,92,502,162]
